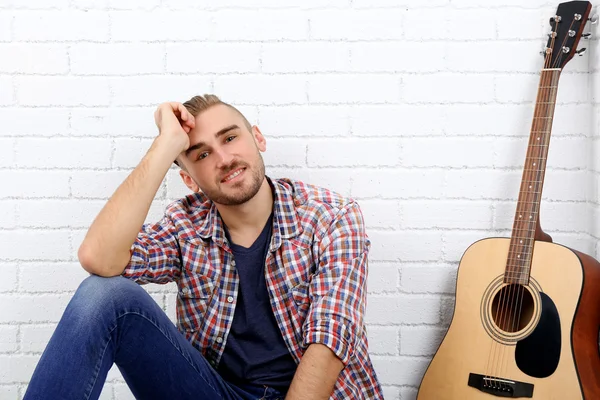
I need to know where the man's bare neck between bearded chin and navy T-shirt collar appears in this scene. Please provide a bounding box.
[216,178,273,245]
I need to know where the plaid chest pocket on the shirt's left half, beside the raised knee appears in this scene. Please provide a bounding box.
[177,275,216,331]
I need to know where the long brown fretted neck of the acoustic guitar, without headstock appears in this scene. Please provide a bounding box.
[504,68,562,285]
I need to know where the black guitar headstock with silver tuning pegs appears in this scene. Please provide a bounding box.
[544,1,596,69]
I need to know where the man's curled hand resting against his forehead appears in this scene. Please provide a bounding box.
[154,102,196,154]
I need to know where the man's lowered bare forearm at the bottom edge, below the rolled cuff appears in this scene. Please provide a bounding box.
[285,343,344,400]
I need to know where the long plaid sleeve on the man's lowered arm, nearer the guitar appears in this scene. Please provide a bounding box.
[303,202,370,365]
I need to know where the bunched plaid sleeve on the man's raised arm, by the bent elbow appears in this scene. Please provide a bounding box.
[122,216,181,284]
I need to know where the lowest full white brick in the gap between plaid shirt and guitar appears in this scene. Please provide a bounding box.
[373,356,429,388]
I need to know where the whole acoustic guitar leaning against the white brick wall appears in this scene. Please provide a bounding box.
[417,1,600,400]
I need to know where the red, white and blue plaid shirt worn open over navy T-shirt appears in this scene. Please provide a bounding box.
[123,178,383,399]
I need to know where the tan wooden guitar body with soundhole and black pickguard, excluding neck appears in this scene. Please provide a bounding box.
[418,238,600,400]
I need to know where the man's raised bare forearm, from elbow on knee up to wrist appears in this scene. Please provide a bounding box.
[78,136,178,276]
